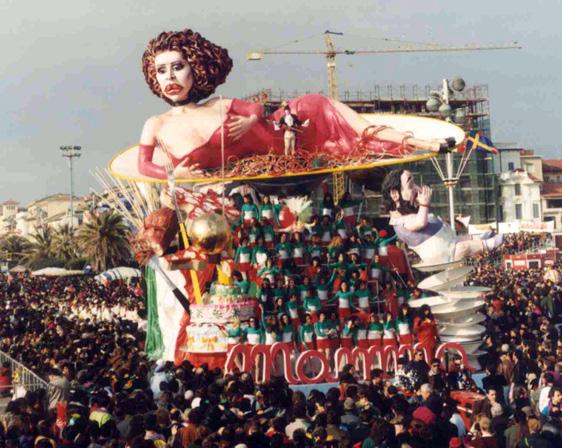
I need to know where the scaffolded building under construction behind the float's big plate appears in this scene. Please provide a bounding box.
[246,85,497,223]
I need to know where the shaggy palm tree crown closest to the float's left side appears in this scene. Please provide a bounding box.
[76,210,131,271]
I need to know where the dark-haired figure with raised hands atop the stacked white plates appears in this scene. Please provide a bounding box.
[382,170,503,264]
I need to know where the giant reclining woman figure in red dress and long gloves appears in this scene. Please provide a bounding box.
[138,29,454,179]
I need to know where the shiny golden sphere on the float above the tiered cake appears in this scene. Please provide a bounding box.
[186,213,231,255]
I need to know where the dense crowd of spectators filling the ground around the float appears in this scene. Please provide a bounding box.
[0,193,562,448]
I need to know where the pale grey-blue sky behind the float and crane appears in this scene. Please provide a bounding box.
[0,0,562,205]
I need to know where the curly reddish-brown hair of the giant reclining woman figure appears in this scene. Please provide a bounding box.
[142,29,232,104]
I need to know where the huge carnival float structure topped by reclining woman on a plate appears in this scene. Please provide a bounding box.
[97,30,499,381]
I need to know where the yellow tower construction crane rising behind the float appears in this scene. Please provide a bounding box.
[246,30,522,201]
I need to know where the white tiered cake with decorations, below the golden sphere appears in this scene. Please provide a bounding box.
[185,283,256,353]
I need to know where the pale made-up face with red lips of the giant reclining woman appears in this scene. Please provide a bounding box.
[154,51,193,101]
